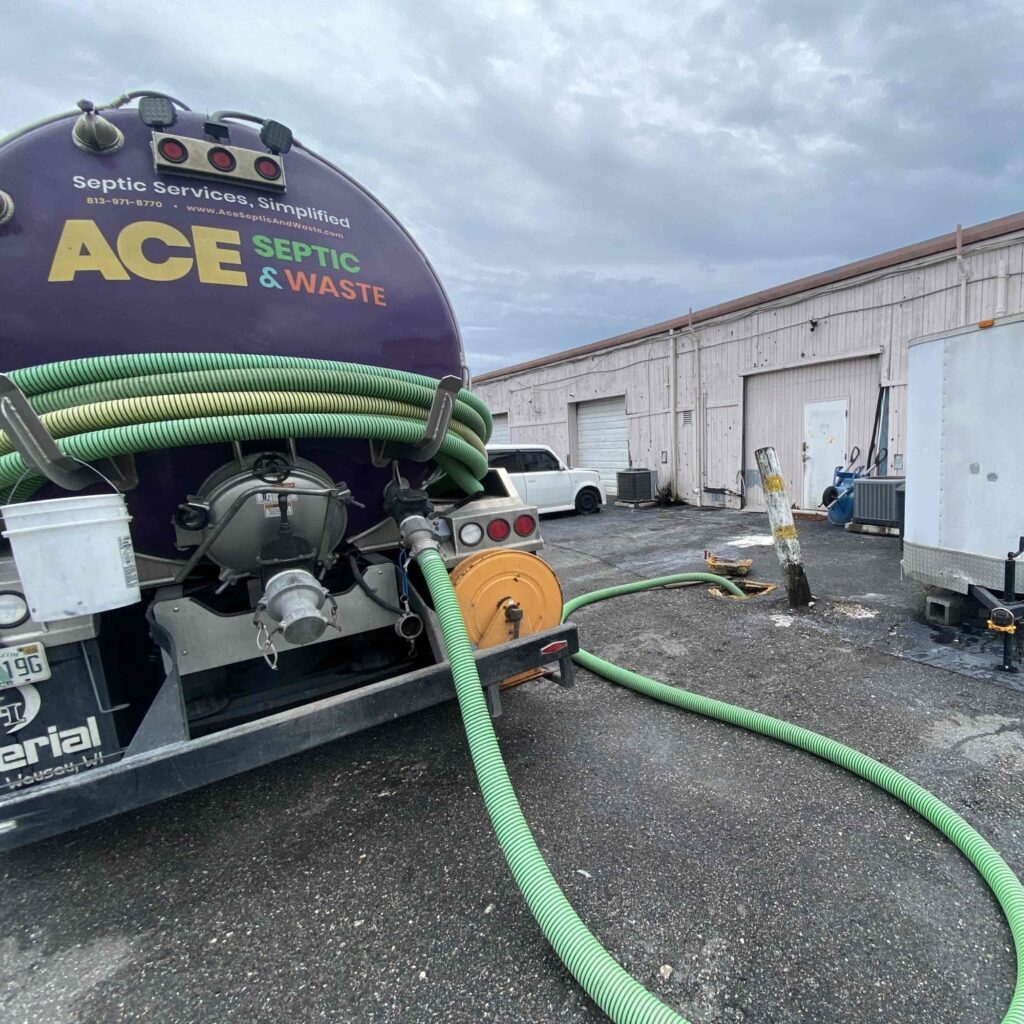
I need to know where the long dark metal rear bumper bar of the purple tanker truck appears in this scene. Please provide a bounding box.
[0,624,580,850]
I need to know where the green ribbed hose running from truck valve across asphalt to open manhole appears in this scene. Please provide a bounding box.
[417,550,1024,1024]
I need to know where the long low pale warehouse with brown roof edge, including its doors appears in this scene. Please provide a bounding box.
[473,213,1024,509]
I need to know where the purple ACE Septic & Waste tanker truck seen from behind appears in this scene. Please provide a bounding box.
[0,92,579,849]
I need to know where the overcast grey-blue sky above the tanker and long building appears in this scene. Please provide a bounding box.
[0,0,1024,373]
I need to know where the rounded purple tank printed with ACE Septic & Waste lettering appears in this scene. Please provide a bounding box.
[0,109,464,557]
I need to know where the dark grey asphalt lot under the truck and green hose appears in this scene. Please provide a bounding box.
[0,508,1024,1024]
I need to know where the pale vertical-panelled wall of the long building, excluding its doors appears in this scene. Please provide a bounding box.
[476,236,1024,507]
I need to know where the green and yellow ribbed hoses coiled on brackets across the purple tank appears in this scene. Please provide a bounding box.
[0,352,490,500]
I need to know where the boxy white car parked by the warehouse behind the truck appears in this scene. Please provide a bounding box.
[487,444,607,514]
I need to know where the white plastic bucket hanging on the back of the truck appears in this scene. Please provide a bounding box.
[0,495,141,623]
